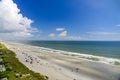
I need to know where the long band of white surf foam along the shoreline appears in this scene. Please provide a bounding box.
[5,43,120,64]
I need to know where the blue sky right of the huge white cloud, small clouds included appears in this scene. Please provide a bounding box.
[0,0,120,40]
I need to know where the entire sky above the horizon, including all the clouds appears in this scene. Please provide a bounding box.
[0,0,120,41]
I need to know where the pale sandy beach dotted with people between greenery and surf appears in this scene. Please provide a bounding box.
[5,43,120,80]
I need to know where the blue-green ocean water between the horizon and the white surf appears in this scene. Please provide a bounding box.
[23,41,120,59]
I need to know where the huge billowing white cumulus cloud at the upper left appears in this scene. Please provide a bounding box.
[0,0,37,37]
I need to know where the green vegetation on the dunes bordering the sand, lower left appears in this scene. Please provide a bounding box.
[0,43,46,80]
